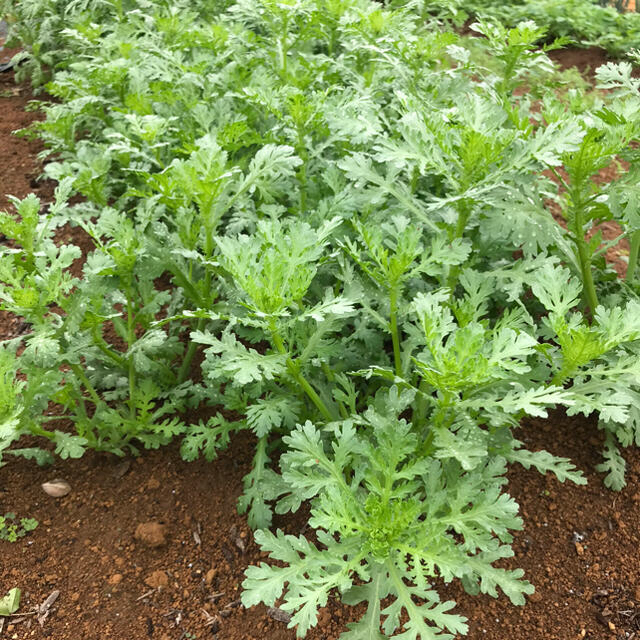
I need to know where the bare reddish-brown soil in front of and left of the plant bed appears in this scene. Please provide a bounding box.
[0,46,640,640]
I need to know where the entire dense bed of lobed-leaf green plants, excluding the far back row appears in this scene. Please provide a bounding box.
[0,0,640,640]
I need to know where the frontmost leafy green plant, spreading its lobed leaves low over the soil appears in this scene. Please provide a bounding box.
[243,400,533,638]
